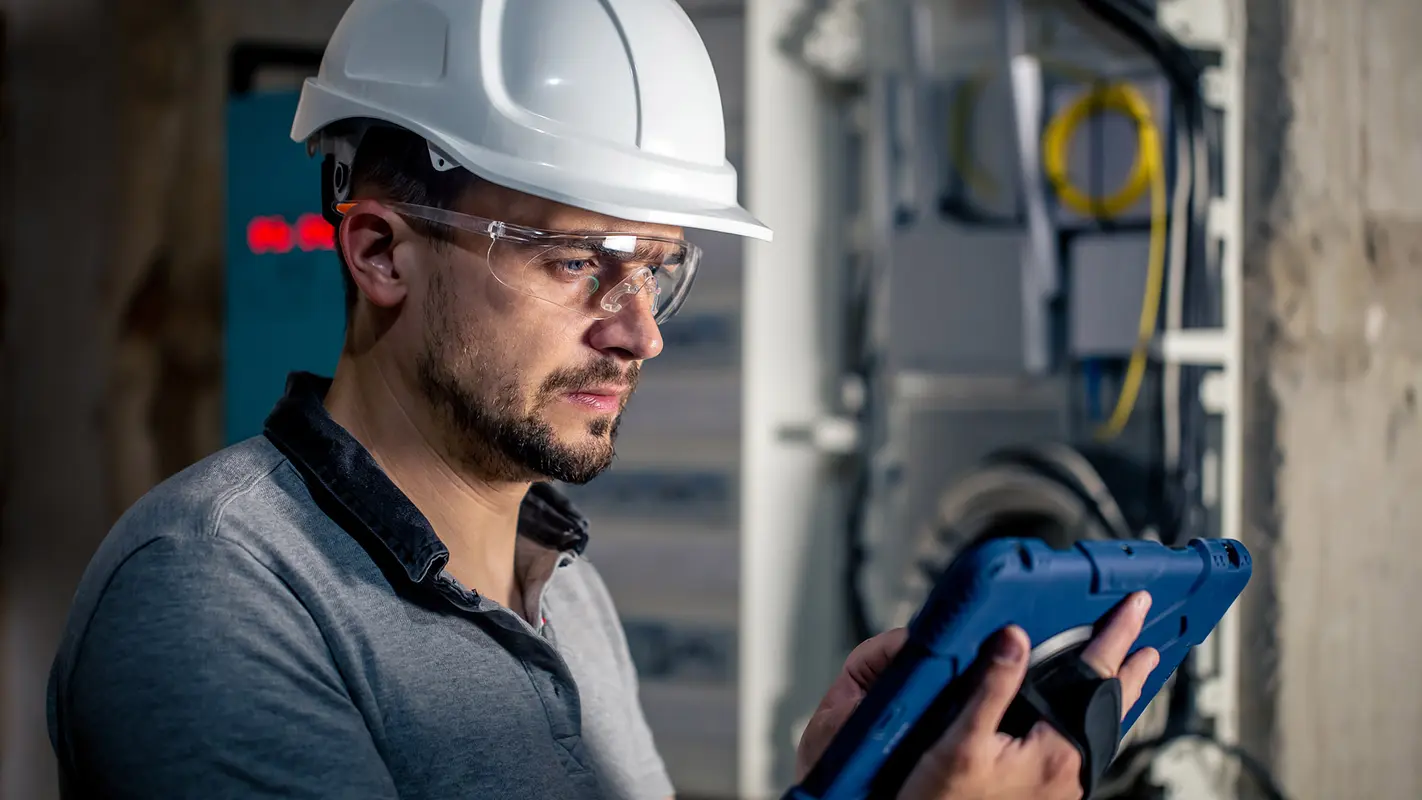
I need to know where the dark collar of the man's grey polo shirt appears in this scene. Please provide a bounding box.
[264,372,587,583]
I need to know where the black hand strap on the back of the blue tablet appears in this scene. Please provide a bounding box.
[1000,658,1122,800]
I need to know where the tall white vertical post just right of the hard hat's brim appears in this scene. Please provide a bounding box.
[738,0,838,799]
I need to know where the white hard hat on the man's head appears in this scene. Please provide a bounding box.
[292,0,771,240]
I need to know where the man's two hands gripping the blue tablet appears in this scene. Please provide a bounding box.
[796,593,1160,800]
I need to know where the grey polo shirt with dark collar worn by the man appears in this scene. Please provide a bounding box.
[48,374,671,800]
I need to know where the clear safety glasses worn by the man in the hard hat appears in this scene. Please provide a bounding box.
[336,203,701,324]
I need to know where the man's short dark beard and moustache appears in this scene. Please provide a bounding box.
[417,298,640,485]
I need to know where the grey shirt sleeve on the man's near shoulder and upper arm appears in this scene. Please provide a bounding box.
[55,536,397,800]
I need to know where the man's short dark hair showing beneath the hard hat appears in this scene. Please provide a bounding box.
[336,125,479,316]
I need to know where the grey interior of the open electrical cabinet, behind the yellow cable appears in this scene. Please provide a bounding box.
[850,0,1167,650]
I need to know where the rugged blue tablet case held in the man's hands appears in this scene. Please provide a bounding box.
[785,539,1251,800]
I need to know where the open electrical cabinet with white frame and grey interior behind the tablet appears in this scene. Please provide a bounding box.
[739,0,1244,800]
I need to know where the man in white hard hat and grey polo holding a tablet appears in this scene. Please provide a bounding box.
[50,0,1152,800]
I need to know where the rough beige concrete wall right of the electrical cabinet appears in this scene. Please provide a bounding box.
[1246,0,1422,800]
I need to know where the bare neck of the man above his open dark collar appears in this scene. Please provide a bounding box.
[326,357,529,612]
